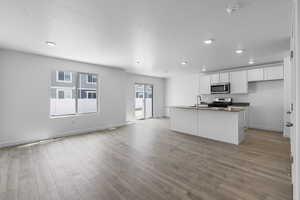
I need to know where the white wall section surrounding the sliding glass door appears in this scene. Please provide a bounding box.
[126,73,165,121]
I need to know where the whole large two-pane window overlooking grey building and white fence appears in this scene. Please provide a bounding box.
[50,71,98,116]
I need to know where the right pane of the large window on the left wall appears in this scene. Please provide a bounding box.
[77,73,98,113]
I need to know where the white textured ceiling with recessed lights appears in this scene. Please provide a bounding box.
[0,0,291,76]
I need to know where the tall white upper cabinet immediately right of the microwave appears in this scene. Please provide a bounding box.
[230,71,248,94]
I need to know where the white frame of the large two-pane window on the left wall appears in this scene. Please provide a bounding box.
[49,70,100,119]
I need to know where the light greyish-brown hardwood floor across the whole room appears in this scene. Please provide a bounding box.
[0,120,292,200]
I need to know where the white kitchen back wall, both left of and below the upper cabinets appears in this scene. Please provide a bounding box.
[166,75,284,131]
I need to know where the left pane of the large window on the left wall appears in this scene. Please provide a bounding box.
[50,71,76,116]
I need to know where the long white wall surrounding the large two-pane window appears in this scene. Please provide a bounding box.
[0,50,126,146]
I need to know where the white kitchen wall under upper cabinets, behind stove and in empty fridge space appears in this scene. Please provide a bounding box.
[208,80,284,131]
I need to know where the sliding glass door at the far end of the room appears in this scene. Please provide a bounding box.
[134,84,153,119]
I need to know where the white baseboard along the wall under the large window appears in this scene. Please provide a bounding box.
[0,122,127,148]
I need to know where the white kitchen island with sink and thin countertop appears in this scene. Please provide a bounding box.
[169,106,246,145]
